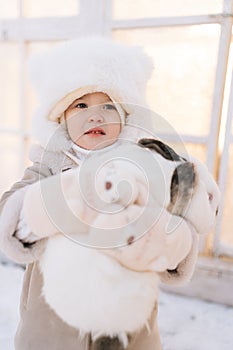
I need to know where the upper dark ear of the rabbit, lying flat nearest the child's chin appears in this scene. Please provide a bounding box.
[138,138,185,161]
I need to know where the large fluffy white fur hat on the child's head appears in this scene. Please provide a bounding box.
[29,37,153,149]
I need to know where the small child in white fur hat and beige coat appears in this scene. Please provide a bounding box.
[0,38,213,350]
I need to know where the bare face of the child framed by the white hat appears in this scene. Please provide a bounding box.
[65,92,121,150]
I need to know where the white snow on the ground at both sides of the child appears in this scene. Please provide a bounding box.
[0,264,233,350]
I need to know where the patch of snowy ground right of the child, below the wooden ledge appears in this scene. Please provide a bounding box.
[159,293,233,350]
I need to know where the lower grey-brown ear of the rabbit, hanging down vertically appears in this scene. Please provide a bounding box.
[167,162,197,216]
